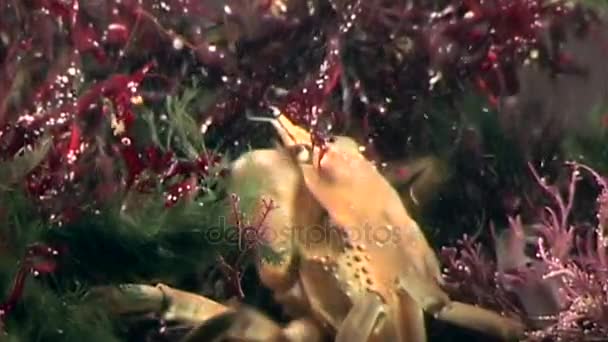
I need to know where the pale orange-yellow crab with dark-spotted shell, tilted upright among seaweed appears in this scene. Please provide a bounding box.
[91,113,525,342]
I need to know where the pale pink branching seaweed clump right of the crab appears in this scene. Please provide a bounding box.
[442,163,608,341]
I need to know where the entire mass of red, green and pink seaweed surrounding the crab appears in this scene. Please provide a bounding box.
[0,0,608,341]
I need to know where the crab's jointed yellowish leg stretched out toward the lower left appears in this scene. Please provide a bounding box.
[89,284,323,342]
